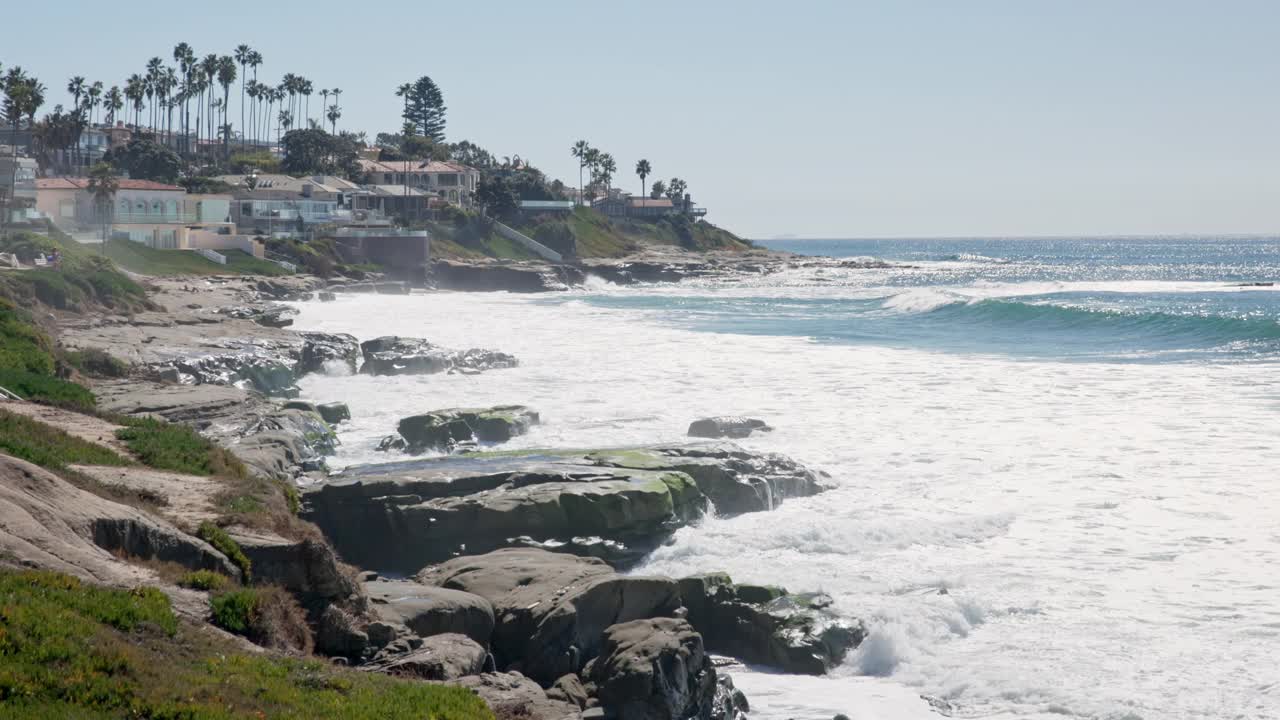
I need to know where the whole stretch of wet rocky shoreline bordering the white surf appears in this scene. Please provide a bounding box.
[27,255,890,720]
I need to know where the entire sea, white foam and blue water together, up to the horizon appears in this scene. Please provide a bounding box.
[288,238,1280,720]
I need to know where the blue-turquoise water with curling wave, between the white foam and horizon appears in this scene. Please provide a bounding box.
[586,237,1280,363]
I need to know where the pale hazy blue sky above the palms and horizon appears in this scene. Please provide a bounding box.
[0,0,1280,238]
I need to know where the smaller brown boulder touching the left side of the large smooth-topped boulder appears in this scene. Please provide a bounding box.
[364,580,494,647]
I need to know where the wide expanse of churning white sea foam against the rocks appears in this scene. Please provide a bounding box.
[296,283,1280,720]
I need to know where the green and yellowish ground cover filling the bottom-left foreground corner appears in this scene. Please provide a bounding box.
[0,573,494,720]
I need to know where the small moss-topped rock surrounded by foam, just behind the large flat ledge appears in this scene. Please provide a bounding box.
[397,405,538,452]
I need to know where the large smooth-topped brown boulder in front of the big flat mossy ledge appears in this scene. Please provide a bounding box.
[417,548,680,684]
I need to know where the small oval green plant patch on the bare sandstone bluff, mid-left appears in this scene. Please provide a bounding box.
[115,418,248,478]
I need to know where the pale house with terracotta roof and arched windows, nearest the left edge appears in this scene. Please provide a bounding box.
[36,178,236,249]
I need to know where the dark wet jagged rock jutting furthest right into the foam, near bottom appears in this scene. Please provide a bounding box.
[680,574,867,675]
